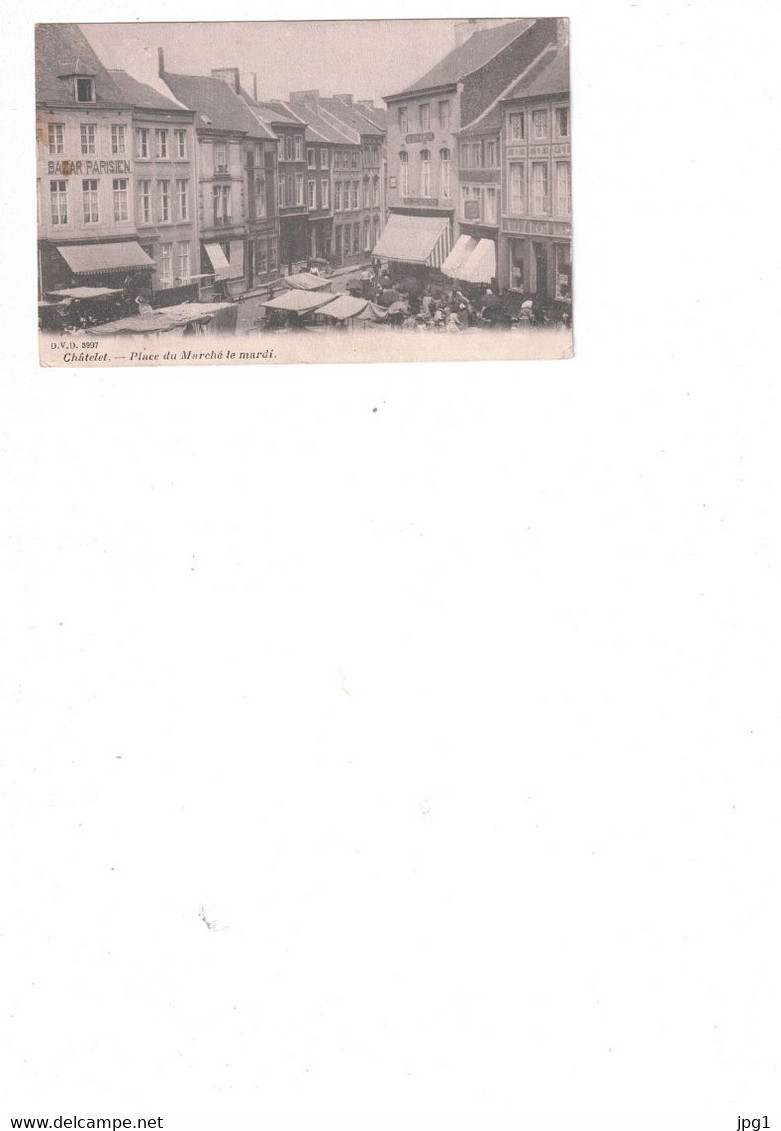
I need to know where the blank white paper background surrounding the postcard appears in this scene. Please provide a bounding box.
[0,0,781,1131]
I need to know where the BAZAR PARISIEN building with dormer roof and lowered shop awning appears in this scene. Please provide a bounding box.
[35,24,155,299]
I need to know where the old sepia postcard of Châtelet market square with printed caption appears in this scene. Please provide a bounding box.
[35,17,573,366]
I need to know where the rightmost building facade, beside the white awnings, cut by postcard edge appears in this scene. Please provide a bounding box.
[500,37,572,305]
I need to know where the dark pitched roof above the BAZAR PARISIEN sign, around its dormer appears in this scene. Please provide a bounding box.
[35,24,123,106]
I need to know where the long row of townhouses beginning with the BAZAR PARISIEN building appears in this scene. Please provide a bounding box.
[36,24,385,304]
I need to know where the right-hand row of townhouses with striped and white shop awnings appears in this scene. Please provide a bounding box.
[376,19,572,303]
